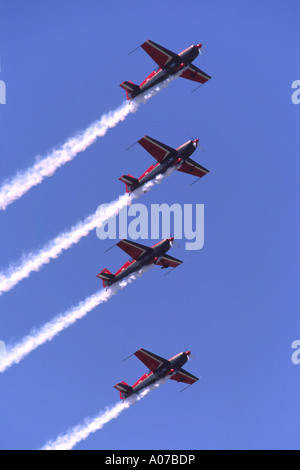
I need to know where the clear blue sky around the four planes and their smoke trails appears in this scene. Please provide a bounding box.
[0,0,300,449]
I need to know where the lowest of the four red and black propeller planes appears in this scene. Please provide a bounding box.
[114,348,199,400]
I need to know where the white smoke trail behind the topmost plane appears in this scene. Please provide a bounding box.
[0,71,183,210]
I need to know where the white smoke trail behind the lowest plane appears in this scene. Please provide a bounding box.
[41,379,166,450]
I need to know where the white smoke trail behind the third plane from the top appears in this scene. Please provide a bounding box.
[0,266,149,373]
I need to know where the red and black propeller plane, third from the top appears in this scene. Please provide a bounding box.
[97,238,182,287]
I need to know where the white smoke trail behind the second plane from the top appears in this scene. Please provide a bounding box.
[0,171,164,296]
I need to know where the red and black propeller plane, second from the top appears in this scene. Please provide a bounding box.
[119,135,209,193]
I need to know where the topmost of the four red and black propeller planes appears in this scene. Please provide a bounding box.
[120,39,211,100]
